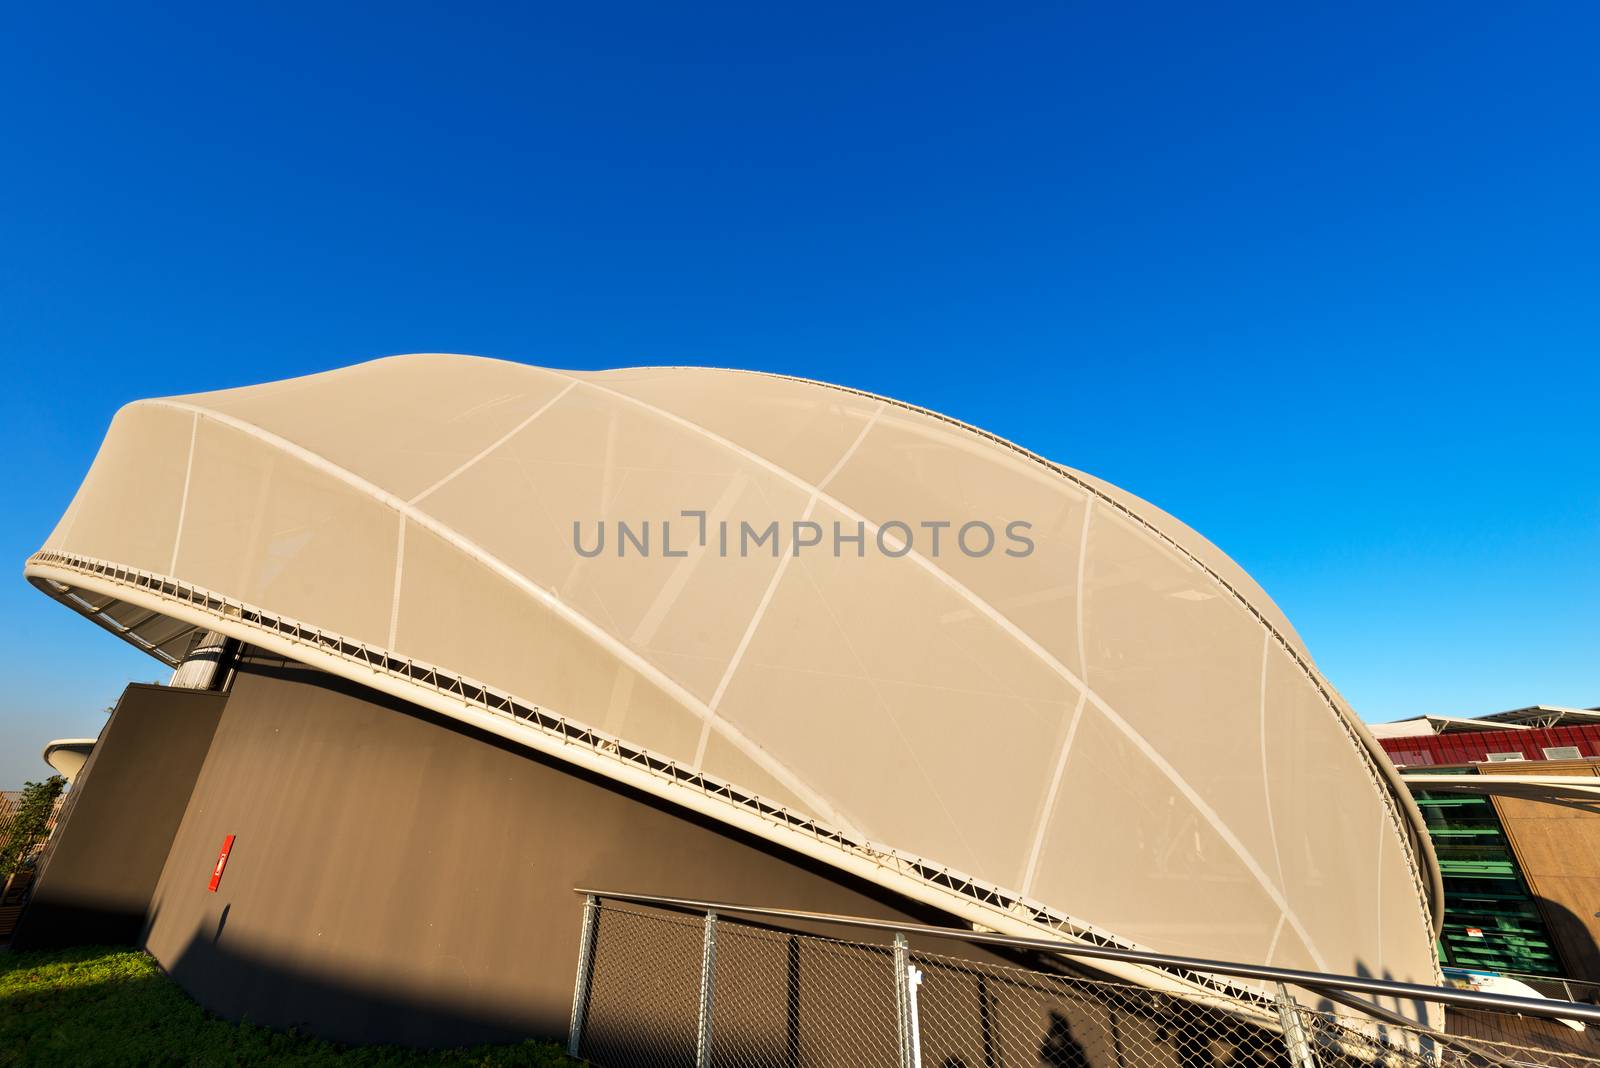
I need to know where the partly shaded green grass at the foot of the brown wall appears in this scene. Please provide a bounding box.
[0,946,576,1068]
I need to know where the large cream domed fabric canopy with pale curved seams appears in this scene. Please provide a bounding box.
[34,355,1438,982]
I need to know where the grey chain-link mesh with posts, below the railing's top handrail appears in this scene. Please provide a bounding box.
[571,900,1600,1068]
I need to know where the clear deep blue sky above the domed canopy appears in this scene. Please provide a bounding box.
[0,3,1600,787]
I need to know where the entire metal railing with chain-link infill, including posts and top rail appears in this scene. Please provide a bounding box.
[568,891,1600,1068]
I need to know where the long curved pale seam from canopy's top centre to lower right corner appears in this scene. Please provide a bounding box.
[558,373,1328,970]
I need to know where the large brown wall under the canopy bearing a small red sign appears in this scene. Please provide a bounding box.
[146,657,949,1046]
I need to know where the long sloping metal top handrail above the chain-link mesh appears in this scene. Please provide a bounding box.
[574,887,1600,1026]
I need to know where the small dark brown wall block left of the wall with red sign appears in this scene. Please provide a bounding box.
[13,684,226,950]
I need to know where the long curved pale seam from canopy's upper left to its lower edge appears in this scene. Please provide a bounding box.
[138,398,859,835]
